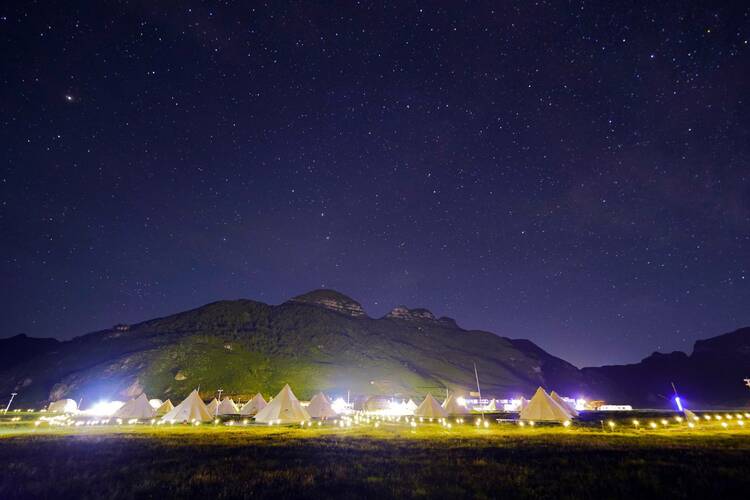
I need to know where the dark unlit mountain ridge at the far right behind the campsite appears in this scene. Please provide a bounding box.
[581,328,750,408]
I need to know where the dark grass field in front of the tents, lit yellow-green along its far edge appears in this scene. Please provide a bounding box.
[0,414,750,499]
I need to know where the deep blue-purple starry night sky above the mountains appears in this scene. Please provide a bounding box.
[0,1,750,366]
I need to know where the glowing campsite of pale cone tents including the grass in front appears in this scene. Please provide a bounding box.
[0,386,750,498]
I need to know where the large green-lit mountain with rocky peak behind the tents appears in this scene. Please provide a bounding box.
[0,290,585,405]
